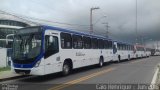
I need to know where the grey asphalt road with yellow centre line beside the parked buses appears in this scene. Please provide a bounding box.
[0,56,160,90]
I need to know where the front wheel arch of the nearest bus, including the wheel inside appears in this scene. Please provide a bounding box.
[62,59,73,76]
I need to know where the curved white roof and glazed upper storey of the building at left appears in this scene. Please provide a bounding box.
[0,14,33,48]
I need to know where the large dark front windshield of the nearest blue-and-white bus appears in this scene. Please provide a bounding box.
[12,27,42,61]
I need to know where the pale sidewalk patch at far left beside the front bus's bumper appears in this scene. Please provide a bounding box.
[0,71,22,81]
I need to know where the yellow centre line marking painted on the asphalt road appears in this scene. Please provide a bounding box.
[49,68,115,90]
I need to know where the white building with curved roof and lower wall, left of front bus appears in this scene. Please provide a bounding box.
[0,13,34,67]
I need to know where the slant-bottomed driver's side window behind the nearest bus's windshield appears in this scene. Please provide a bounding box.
[45,35,59,58]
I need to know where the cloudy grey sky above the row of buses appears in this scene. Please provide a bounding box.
[0,0,160,46]
